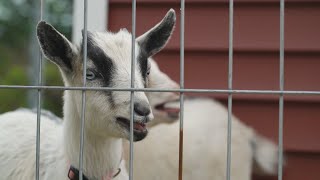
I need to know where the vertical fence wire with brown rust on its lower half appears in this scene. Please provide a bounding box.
[179,0,185,180]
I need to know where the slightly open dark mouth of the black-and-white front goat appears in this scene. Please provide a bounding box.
[116,117,148,141]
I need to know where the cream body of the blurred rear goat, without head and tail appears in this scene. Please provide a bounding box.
[125,99,253,180]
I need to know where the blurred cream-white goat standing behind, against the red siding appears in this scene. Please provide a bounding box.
[124,60,277,180]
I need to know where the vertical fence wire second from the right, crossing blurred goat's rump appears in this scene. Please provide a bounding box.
[226,0,233,180]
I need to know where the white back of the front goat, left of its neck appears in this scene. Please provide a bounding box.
[0,111,67,180]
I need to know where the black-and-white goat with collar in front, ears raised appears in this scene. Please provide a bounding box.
[0,9,175,180]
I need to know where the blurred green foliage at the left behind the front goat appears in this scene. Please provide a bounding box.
[0,0,73,116]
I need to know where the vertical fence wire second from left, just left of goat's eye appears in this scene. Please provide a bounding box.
[79,0,88,180]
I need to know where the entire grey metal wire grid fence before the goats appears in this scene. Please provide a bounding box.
[0,0,320,180]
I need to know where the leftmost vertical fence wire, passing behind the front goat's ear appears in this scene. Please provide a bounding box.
[36,0,43,180]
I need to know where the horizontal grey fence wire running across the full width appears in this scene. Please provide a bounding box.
[0,85,320,96]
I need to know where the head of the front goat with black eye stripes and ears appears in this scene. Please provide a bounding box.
[37,9,176,141]
